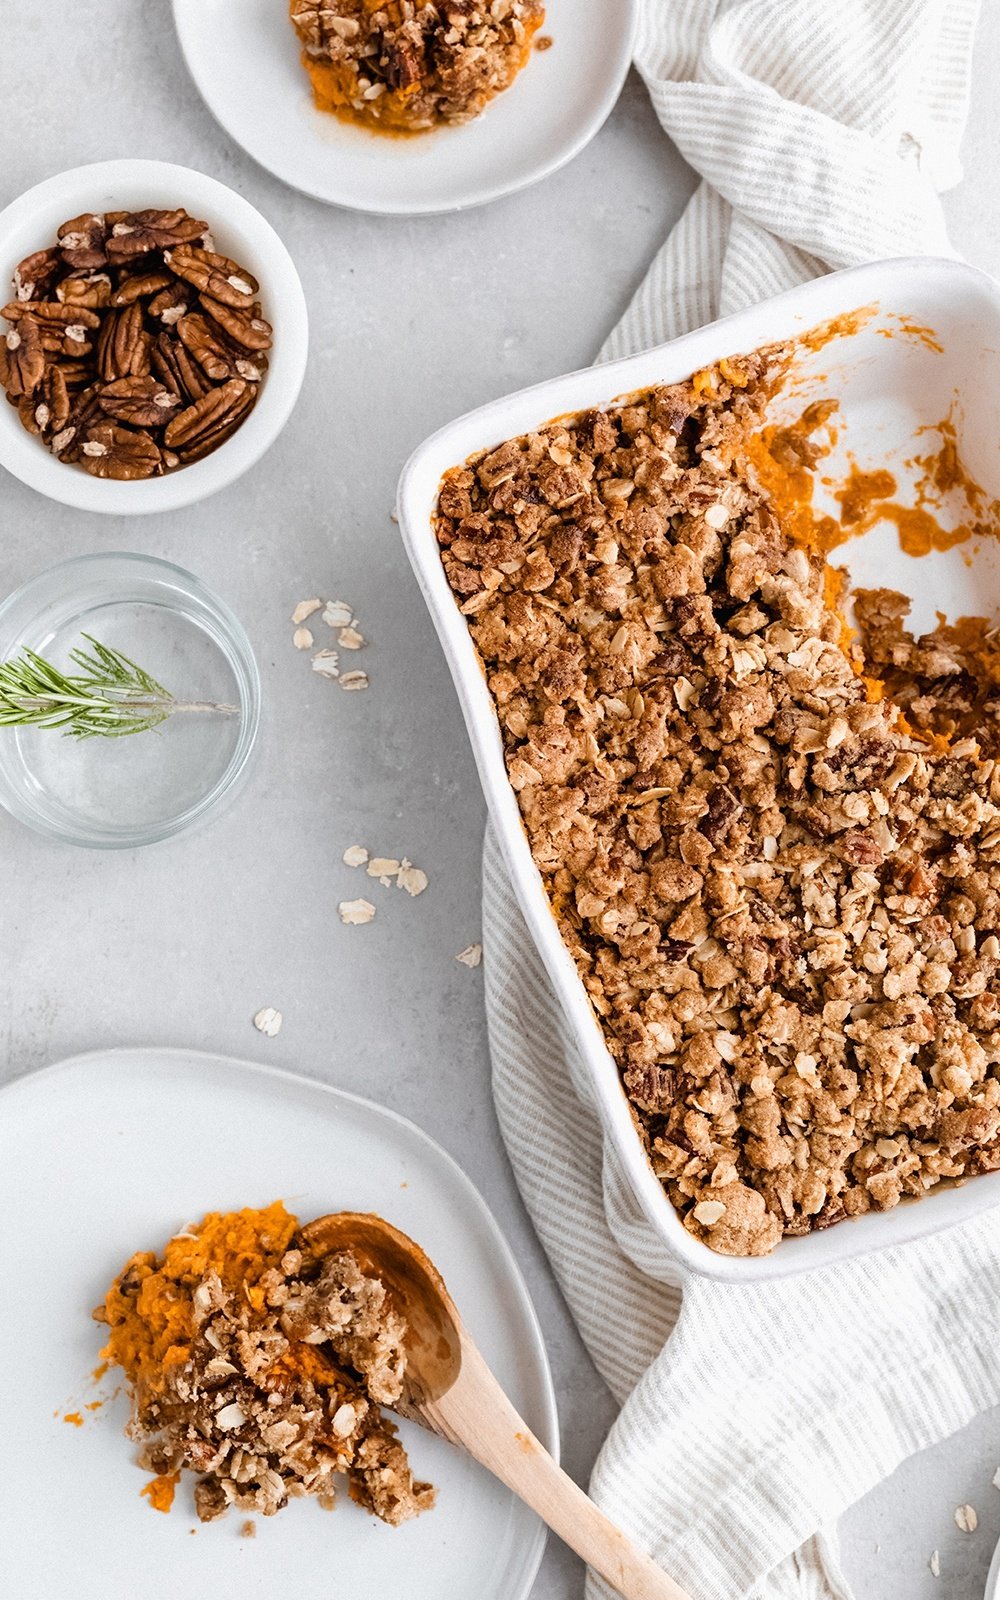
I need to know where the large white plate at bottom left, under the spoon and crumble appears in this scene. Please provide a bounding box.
[0,1050,557,1600]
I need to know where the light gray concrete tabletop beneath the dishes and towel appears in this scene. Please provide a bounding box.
[0,0,1000,1600]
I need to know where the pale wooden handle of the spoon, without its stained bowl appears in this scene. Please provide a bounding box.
[422,1339,691,1600]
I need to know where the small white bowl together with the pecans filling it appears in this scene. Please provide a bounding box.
[0,160,309,515]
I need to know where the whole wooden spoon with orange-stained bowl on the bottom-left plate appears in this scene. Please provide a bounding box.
[302,1211,690,1600]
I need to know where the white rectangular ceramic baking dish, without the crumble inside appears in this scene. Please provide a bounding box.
[398,258,1000,1282]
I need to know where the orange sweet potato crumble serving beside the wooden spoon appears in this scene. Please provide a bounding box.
[94,1202,434,1533]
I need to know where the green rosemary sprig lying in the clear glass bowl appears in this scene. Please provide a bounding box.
[0,634,240,739]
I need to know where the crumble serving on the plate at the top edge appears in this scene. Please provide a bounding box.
[290,0,546,133]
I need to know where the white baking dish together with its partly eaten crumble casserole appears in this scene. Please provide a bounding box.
[400,261,1000,1277]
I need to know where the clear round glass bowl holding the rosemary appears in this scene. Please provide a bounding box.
[0,552,261,850]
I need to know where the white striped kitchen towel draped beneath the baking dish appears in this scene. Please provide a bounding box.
[483,0,1000,1600]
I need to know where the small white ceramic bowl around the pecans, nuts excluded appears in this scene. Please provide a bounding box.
[0,160,309,517]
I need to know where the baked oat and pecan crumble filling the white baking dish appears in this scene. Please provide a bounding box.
[437,350,1000,1254]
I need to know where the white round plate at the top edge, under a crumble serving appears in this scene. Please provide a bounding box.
[173,0,637,216]
